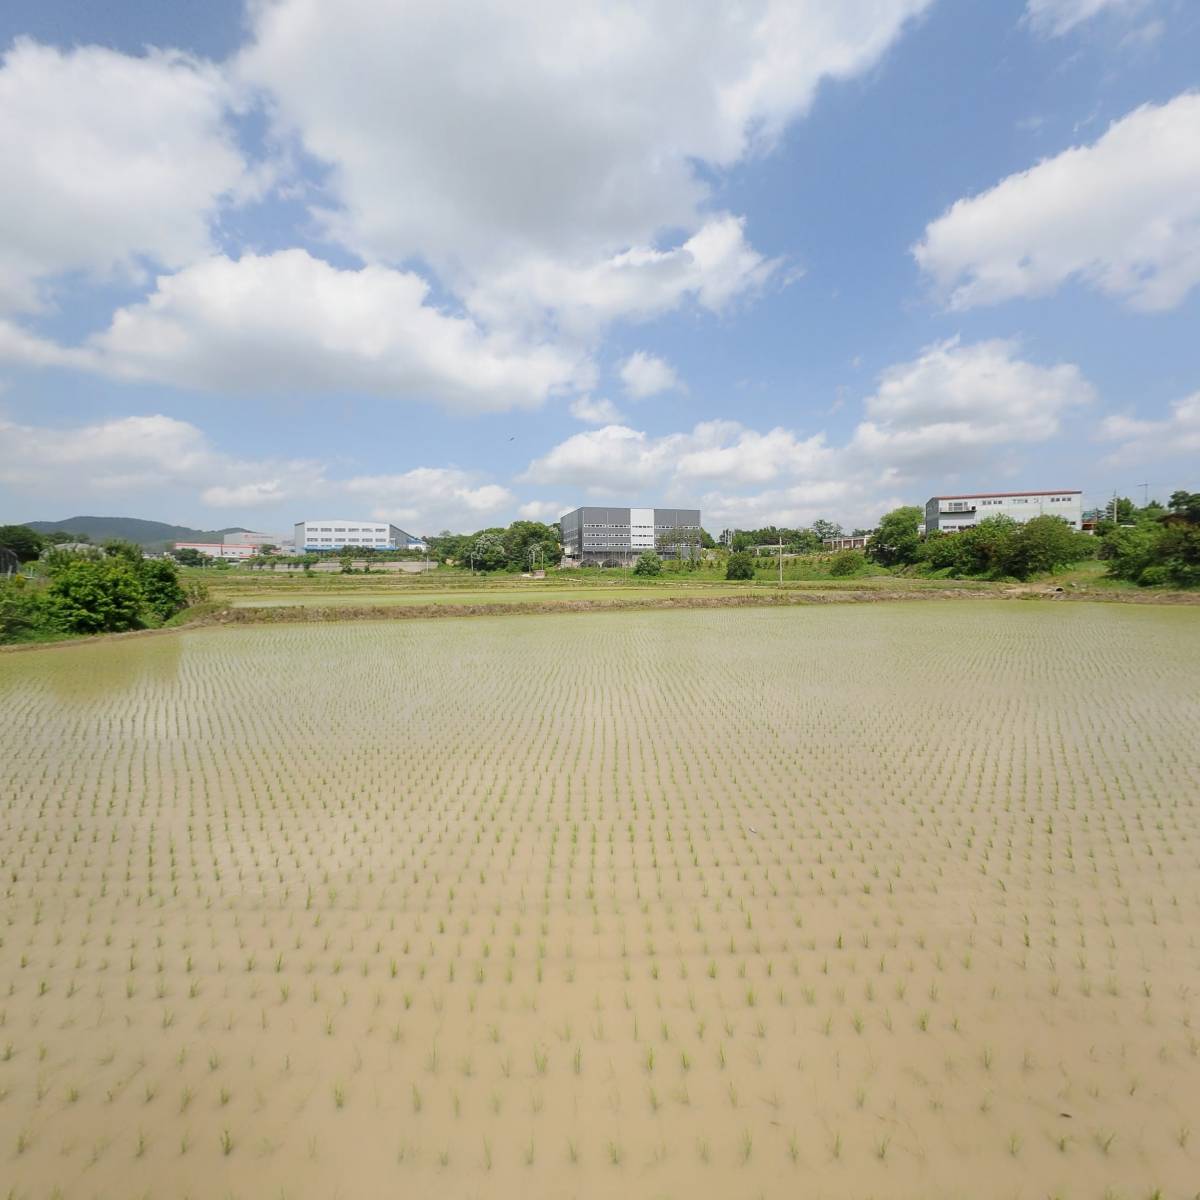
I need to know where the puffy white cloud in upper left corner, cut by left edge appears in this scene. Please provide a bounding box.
[0,38,256,311]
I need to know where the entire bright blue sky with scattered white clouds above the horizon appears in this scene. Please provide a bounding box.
[0,0,1200,533]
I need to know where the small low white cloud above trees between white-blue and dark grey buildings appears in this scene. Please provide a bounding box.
[343,467,516,534]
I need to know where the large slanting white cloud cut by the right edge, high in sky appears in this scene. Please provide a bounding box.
[913,92,1200,311]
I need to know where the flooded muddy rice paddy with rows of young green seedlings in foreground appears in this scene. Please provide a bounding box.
[0,600,1200,1200]
